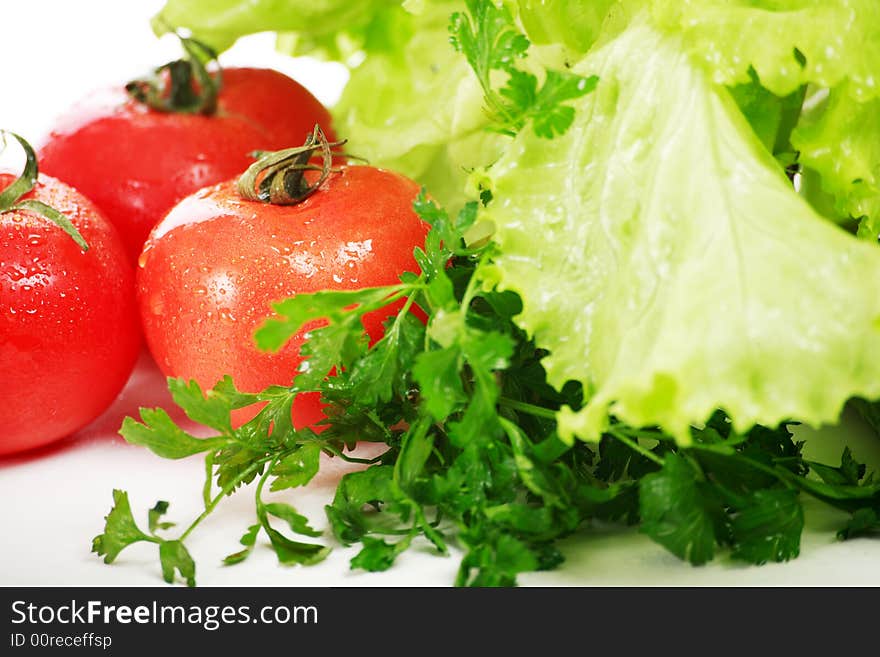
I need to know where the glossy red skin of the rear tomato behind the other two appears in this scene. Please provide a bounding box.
[38,68,332,264]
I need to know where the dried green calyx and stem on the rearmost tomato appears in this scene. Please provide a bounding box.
[125,32,223,115]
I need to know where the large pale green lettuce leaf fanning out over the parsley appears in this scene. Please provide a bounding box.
[487,20,880,443]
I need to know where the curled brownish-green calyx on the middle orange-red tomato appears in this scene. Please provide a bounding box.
[236,124,346,205]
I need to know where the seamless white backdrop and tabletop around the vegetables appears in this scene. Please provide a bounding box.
[0,0,880,586]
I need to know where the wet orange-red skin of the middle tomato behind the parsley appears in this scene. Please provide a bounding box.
[137,166,427,427]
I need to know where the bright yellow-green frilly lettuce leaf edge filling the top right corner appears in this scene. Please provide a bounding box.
[653,0,880,99]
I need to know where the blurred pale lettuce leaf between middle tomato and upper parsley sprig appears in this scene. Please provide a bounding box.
[333,2,509,207]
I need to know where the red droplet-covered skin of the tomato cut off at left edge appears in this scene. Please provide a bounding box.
[0,174,141,455]
